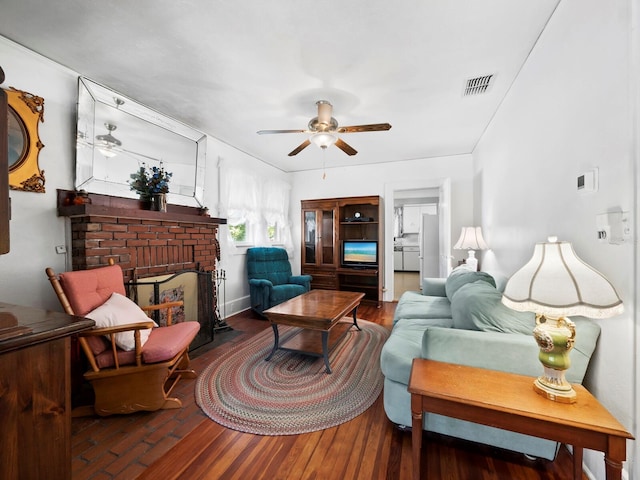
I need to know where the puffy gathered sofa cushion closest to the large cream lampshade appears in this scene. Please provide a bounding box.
[451,281,536,335]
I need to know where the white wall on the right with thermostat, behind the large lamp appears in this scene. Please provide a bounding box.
[473,0,640,478]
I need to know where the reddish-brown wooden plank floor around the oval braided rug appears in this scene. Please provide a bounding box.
[72,303,587,480]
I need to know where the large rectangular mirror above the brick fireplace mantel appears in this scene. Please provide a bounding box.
[75,77,207,207]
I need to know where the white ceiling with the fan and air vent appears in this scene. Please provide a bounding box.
[0,0,560,172]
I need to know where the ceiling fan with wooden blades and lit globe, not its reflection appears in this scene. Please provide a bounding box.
[258,100,391,157]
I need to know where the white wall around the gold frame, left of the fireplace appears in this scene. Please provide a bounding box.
[0,37,78,309]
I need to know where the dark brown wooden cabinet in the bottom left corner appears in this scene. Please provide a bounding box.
[0,302,95,480]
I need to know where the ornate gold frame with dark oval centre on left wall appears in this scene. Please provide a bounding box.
[5,87,45,193]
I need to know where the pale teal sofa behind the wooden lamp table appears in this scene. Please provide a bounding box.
[380,268,600,460]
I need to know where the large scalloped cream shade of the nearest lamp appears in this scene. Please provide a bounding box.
[502,237,624,318]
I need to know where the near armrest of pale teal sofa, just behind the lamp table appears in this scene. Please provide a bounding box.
[421,327,544,381]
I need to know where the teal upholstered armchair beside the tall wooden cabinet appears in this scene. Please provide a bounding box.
[247,247,311,315]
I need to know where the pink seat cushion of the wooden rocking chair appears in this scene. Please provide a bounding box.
[96,322,200,368]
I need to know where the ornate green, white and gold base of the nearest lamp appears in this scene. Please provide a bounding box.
[533,315,576,403]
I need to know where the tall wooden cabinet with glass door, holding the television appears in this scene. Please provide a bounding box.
[301,196,384,303]
